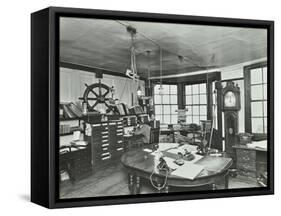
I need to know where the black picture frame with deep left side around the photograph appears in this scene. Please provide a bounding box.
[31,7,274,208]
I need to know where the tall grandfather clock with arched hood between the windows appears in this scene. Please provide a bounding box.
[216,81,241,158]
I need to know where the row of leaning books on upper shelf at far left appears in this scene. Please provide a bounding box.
[60,102,83,119]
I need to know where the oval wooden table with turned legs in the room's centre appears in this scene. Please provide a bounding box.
[121,147,232,194]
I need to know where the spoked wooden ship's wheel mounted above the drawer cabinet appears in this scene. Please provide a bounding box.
[79,80,114,113]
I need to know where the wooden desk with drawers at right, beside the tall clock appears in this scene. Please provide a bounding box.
[233,145,267,178]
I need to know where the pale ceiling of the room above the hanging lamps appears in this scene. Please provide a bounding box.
[60,18,267,77]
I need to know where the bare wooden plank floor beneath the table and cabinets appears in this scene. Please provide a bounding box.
[60,161,259,199]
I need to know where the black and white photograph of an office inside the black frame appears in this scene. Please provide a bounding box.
[57,16,269,200]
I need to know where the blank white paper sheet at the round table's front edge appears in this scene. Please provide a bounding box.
[172,163,204,180]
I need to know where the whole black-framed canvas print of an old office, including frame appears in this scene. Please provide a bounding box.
[31,7,274,208]
